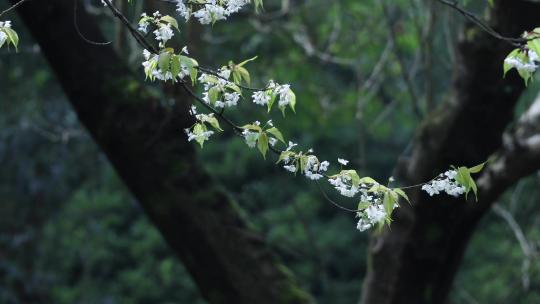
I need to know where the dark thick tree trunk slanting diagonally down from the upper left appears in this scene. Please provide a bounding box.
[12,0,312,304]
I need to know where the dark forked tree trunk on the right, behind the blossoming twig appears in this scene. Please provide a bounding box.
[362,0,540,304]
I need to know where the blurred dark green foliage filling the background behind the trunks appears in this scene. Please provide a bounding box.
[0,0,540,304]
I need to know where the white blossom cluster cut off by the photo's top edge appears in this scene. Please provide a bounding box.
[176,0,249,24]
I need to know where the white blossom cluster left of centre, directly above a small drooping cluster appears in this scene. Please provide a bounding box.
[199,68,240,108]
